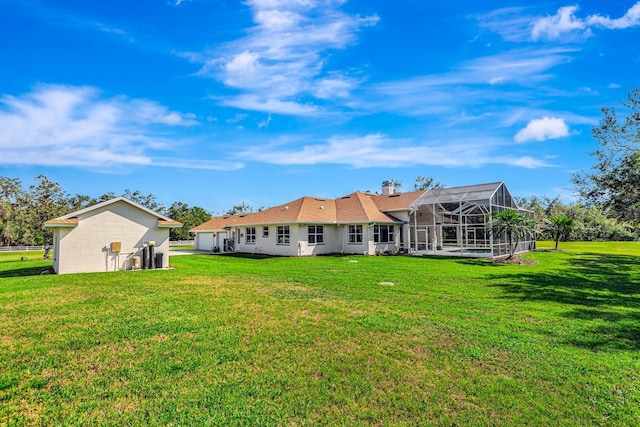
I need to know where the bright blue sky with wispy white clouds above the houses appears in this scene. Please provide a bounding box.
[0,0,640,212]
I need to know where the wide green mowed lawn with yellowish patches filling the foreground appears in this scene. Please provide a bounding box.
[0,246,640,426]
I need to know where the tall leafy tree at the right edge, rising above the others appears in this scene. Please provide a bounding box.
[572,88,640,228]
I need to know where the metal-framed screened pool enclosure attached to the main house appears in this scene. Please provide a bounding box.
[408,182,536,257]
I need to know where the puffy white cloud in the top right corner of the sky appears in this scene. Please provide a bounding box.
[531,2,640,40]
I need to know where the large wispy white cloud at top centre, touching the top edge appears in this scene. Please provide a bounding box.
[188,0,378,114]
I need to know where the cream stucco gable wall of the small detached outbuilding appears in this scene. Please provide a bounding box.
[54,201,169,274]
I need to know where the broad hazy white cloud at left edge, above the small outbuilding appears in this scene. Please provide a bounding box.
[0,85,242,169]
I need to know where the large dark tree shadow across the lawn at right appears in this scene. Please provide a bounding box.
[488,253,640,350]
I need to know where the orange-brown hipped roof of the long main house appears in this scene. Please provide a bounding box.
[190,192,413,232]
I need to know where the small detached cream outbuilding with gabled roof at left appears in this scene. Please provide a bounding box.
[44,197,182,274]
